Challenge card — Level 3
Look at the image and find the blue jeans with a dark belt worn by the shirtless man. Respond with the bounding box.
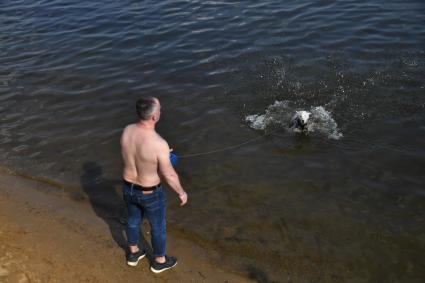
[123,182,167,257]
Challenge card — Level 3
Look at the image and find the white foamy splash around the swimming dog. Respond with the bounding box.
[245,101,343,140]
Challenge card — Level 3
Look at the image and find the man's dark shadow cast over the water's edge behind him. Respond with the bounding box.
[80,162,153,260]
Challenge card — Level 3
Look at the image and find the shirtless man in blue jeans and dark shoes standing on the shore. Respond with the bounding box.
[121,97,187,273]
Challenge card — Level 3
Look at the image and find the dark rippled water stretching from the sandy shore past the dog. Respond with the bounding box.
[0,0,425,282]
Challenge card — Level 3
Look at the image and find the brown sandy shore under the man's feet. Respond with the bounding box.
[0,172,252,283]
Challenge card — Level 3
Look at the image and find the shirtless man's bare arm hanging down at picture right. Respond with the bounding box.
[158,141,187,205]
